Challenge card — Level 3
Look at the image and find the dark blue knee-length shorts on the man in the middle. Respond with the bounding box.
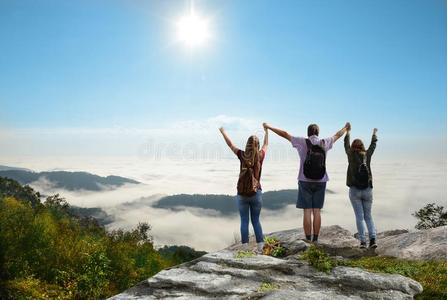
[296,181,326,209]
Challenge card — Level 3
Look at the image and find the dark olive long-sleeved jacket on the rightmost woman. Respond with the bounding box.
[345,132,377,188]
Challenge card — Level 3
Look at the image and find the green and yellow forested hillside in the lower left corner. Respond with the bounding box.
[0,177,203,299]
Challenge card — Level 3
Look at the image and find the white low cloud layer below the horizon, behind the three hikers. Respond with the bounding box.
[4,157,447,250]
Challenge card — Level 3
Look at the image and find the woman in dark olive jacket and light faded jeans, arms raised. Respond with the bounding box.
[345,128,377,248]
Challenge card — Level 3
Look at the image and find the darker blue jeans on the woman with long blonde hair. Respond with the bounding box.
[236,190,264,243]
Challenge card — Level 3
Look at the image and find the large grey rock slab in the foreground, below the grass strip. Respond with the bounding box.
[112,250,422,300]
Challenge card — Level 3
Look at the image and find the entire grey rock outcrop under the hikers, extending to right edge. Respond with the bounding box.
[107,226,447,300]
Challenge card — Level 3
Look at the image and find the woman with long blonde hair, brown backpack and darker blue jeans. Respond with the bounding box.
[219,127,268,253]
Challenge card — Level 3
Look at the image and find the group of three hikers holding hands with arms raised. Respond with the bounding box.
[220,123,377,252]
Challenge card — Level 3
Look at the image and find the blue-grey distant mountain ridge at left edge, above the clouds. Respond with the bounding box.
[0,167,140,191]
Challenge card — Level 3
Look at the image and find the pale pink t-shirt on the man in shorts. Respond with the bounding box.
[291,135,334,182]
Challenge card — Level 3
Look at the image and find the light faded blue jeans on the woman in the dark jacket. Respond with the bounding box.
[349,187,376,242]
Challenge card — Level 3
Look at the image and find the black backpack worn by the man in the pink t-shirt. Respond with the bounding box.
[303,139,326,180]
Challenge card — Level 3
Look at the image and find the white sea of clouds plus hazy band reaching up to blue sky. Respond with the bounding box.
[0,115,447,250]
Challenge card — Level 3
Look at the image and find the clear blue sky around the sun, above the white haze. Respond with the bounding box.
[0,0,447,158]
